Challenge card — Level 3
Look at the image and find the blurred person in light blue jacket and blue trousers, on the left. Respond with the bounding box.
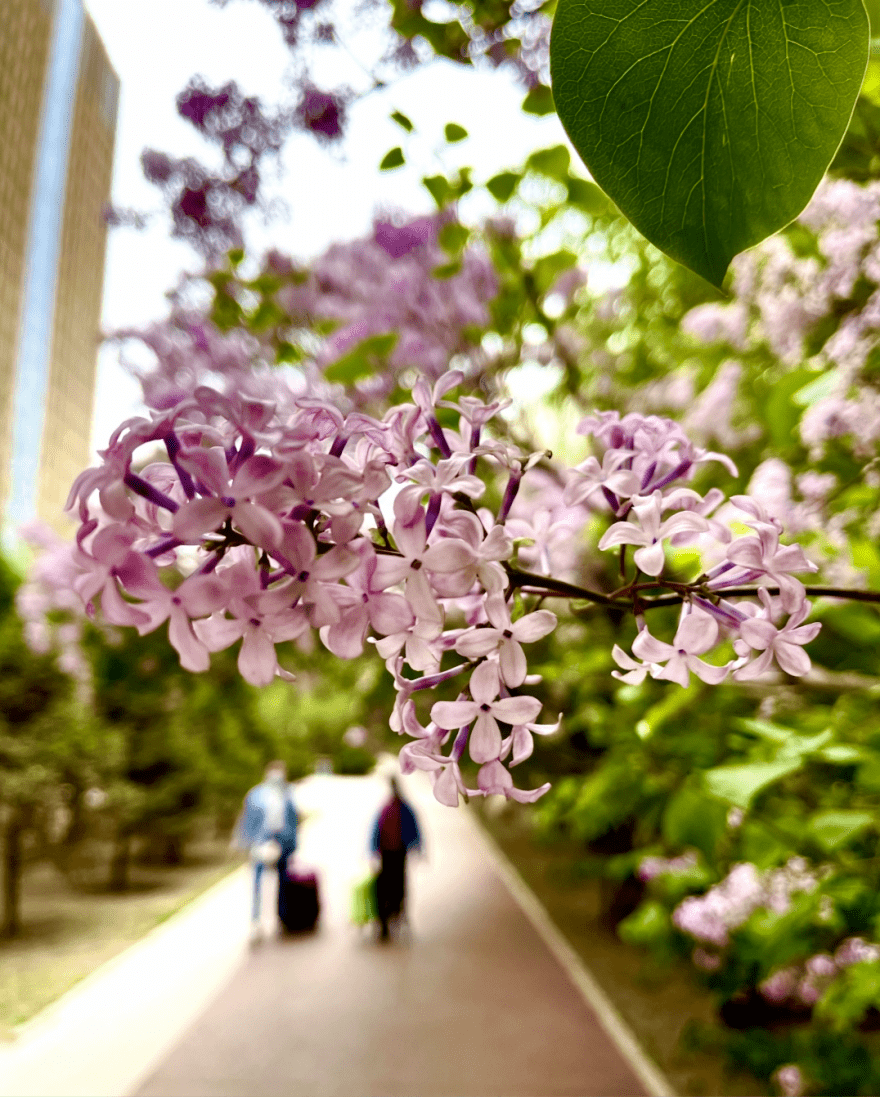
[236,761,298,940]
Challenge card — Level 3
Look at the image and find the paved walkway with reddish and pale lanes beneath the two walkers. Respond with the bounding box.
[0,763,668,1097]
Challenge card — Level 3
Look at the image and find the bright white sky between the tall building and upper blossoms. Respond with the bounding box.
[80,0,565,450]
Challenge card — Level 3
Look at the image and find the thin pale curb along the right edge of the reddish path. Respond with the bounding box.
[465,807,677,1097]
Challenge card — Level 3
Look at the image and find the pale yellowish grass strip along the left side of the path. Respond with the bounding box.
[0,841,241,1039]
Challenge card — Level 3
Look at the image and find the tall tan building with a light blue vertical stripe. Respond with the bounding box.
[0,0,119,540]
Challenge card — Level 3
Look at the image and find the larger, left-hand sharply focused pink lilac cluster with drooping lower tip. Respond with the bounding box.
[68,372,556,805]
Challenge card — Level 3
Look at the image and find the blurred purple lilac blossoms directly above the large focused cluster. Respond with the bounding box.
[120,212,498,410]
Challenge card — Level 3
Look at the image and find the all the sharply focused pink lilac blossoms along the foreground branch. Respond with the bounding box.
[61,379,819,805]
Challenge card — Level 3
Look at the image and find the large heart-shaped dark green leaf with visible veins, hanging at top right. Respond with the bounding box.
[550,0,868,285]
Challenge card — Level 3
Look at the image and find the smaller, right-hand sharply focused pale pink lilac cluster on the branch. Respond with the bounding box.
[565,411,820,686]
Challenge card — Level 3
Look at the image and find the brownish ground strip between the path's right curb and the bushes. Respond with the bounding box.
[477,804,769,1097]
